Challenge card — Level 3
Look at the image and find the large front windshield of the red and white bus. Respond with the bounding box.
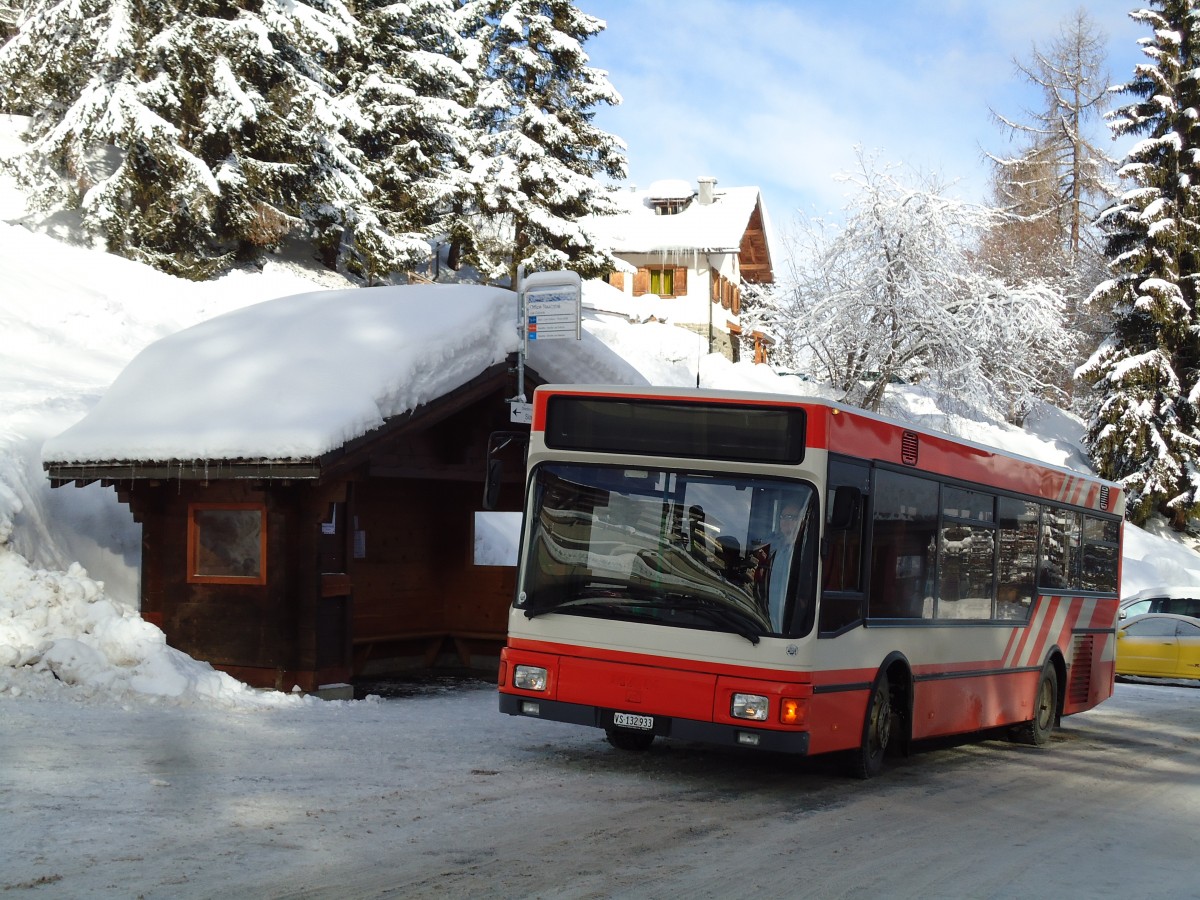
[516,463,818,643]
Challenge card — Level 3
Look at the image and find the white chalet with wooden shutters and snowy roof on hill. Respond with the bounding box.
[586,178,775,362]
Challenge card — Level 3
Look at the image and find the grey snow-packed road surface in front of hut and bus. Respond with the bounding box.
[0,684,1200,900]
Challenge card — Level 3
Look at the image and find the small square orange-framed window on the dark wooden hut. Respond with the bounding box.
[187,503,266,584]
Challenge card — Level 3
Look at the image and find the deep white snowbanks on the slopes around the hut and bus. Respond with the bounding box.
[0,114,1200,708]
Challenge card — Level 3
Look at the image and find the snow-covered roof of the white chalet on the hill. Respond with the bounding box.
[584,182,762,253]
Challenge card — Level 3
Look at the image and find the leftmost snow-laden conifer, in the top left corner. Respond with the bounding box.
[0,0,220,273]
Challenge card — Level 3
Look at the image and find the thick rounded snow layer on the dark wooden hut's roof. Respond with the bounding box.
[43,284,647,464]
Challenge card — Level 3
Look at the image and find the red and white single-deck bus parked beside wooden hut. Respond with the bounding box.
[499,385,1124,778]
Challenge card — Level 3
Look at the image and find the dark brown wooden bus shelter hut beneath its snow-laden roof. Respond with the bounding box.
[46,362,540,691]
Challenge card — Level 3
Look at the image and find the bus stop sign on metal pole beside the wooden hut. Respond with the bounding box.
[509,265,583,425]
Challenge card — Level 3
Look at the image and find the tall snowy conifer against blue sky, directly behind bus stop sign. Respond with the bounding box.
[460,0,625,280]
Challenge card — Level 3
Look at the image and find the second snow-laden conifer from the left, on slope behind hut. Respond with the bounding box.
[171,0,372,269]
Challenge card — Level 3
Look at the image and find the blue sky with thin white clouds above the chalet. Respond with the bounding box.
[577,0,1148,229]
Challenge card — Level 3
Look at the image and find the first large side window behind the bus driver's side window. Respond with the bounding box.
[866,470,938,619]
